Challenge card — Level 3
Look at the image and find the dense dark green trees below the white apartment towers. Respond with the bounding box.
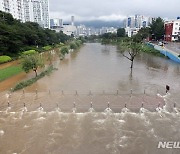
[0,11,69,55]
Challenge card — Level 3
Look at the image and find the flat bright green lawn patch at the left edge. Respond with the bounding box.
[0,65,23,82]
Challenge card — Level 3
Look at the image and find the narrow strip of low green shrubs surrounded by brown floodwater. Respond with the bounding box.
[11,66,55,92]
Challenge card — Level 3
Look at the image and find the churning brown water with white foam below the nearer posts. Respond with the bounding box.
[0,103,180,154]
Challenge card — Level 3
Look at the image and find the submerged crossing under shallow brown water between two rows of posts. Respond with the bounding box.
[0,91,167,113]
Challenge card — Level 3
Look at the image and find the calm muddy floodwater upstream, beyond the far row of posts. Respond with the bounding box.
[27,43,180,93]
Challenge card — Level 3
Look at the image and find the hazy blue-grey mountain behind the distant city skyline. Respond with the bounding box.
[63,20,123,28]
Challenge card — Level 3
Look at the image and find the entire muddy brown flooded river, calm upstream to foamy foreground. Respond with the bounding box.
[0,43,180,154]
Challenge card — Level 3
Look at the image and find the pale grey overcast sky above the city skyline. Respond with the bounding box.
[49,0,180,21]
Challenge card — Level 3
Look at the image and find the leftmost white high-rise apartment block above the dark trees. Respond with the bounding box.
[0,0,24,21]
